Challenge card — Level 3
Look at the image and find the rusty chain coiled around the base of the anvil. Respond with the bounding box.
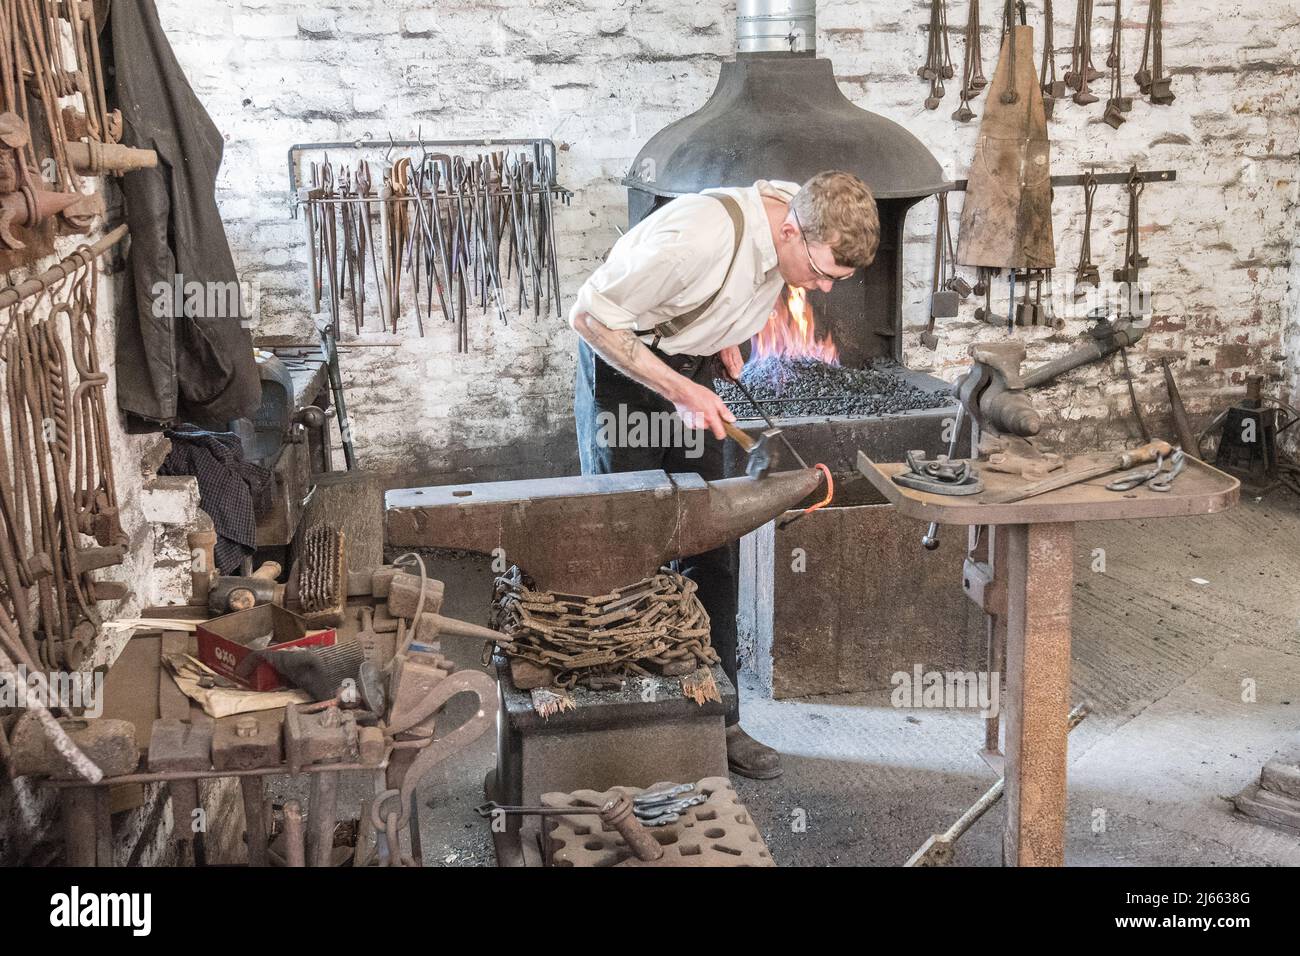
[493,567,719,688]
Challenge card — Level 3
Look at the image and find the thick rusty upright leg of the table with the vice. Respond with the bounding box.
[1002,523,1074,866]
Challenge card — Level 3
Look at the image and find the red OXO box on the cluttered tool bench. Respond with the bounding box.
[195,604,337,691]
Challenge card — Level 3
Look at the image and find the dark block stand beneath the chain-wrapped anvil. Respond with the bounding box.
[484,653,736,866]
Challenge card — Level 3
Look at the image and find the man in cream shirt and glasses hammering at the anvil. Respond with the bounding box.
[569,172,880,779]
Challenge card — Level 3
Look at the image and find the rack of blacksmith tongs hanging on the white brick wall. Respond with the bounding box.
[289,139,573,352]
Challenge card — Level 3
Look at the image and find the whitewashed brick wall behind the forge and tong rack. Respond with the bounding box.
[159,0,1300,475]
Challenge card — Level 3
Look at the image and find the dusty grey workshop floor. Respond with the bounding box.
[276,481,1300,866]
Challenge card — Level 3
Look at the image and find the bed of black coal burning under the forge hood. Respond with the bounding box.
[714,356,953,419]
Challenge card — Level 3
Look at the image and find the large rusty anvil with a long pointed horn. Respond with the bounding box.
[384,468,822,594]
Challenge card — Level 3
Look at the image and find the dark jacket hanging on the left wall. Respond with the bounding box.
[105,0,261,428]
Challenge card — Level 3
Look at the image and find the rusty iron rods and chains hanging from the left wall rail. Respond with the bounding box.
[0,233,126,669]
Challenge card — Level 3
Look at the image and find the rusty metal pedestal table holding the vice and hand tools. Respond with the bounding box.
[858,453,1240,866]
